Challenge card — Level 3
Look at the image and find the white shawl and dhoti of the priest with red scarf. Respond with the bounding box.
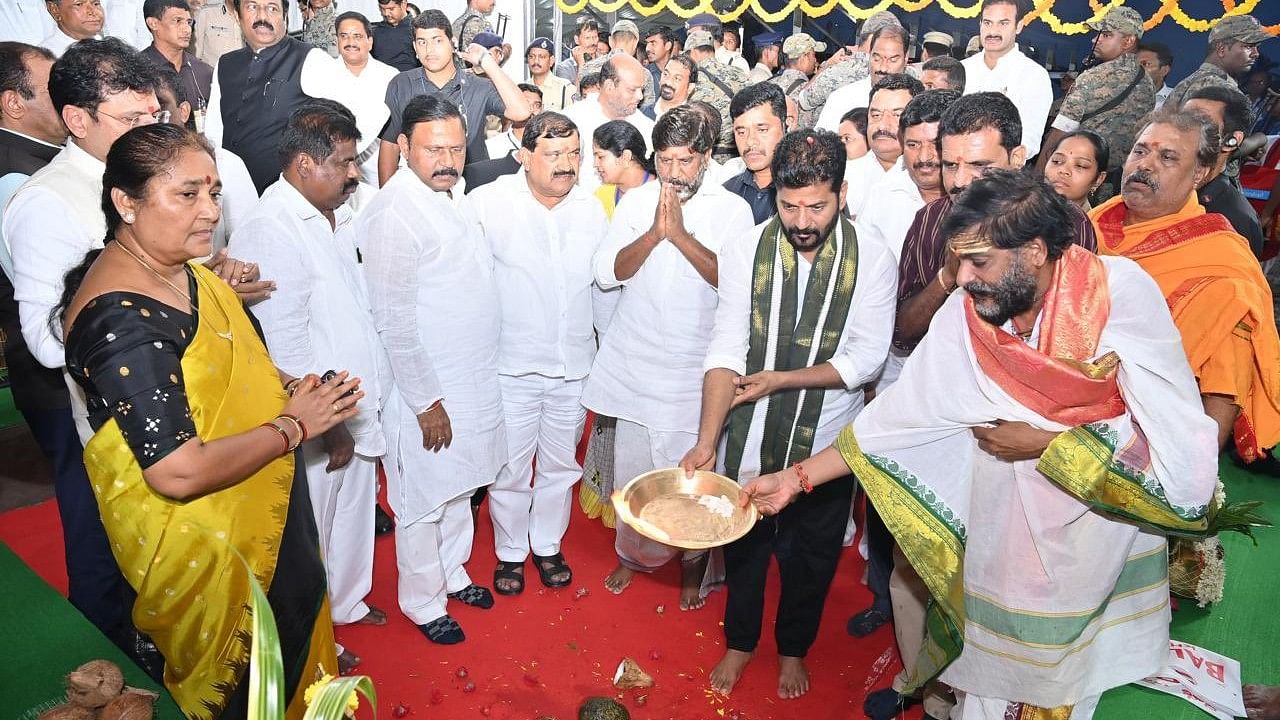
[854,258,1217,719]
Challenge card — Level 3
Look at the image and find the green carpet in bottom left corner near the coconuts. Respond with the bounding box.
[0,542,183,720]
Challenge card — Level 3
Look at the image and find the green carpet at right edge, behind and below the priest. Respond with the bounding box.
[1094,457,1280,720]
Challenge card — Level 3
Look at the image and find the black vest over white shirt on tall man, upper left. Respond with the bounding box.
[218,37,311,195]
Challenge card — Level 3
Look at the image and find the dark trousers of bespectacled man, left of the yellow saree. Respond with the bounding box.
[23,409,133,638]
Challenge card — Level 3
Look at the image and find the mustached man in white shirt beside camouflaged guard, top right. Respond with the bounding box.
[960,0,1053,152]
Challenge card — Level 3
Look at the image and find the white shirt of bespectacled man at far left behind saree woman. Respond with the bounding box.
[3,140,106,368]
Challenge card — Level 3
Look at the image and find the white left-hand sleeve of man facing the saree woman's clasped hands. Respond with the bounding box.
[227,215,314,378]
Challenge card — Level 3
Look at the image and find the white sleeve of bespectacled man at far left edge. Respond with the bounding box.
[4,187,91,368]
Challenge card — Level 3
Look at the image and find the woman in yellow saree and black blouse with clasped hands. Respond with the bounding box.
[61,124,364,719]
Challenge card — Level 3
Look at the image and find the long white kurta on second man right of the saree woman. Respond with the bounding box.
[356,170,506,524]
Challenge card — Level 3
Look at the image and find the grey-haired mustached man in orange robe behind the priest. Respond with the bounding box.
[1089,110,1280,462]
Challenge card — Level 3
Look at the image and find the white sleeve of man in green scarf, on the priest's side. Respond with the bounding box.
[829,229,897,389]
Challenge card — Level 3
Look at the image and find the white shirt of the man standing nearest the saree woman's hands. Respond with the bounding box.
[228,177,390,457]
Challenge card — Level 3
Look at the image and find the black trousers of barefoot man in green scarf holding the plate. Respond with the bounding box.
[724,477,854,657]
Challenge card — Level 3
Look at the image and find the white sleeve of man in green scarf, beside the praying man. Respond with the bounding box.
[703,228,760,375]
